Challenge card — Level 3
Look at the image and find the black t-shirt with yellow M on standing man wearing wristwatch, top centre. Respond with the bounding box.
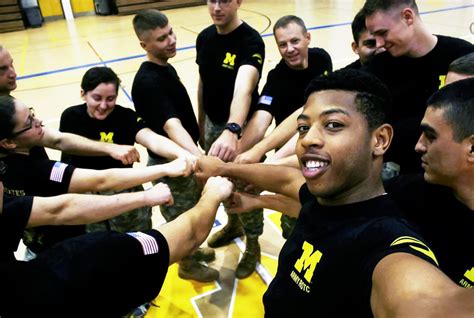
[196,22,265,124]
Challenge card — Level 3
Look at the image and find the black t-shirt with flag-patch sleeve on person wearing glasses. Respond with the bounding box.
[3,154,85,253]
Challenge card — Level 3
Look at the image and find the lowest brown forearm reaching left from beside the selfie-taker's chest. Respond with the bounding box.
[226,192,301,218]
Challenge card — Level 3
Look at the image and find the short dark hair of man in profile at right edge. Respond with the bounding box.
[426,78,474,142]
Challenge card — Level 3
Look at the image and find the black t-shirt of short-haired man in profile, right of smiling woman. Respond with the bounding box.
[132,62,199,158]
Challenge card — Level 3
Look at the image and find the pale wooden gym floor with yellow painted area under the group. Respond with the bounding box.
[4,0,474,317]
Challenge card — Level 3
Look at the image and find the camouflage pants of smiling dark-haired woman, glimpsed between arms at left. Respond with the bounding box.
[86,185,152,233]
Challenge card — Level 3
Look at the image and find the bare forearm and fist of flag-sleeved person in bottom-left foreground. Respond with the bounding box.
[158,177,233,264]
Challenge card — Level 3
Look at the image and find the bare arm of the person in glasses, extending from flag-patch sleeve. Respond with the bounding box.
[68,158,194,193]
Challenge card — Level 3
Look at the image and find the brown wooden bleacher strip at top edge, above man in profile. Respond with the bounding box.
[115,0,206,15]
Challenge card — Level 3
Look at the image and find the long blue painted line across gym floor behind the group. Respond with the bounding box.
[17,5,474,82]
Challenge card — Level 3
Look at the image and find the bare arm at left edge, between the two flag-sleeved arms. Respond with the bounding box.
[27,183,173,227]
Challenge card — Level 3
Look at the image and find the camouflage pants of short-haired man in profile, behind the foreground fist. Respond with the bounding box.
[148,158,201,222]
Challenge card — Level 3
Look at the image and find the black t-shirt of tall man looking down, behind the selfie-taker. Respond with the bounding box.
[363,35,474,173]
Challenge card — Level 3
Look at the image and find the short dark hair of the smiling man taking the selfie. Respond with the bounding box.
[305,69,391,131]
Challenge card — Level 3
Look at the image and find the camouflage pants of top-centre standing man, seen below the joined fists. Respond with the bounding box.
[204,116,263,238]
